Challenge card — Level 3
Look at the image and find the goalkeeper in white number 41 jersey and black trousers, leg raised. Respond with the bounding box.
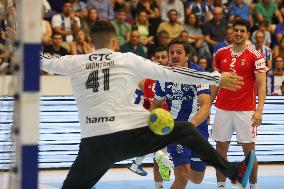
[42,21,255,189]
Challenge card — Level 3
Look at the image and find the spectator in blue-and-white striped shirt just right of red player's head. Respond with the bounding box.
[254,31,272,69]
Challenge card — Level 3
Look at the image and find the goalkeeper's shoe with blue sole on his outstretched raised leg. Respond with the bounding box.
[232,151,255,189]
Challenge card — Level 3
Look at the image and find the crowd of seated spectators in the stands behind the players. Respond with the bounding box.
[0,0,284,95]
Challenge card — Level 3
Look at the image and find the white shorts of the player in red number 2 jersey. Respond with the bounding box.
[210,108,257,143]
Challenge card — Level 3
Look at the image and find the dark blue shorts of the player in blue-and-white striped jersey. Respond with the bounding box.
[167,125,208,172]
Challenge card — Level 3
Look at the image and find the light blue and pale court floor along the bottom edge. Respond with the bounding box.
[35,164,284,189]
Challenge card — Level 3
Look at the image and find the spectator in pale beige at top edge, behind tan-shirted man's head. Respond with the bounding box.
[160,0,184,24]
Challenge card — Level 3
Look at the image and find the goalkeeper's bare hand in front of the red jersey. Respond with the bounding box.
[219,72,244,91]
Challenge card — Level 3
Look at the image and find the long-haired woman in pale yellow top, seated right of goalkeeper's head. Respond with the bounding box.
[135,10,154,46]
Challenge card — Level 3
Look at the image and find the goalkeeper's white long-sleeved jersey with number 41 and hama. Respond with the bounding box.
[41,49,220,138]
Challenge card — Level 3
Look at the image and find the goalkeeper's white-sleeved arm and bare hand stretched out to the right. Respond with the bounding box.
[128,53,242,90]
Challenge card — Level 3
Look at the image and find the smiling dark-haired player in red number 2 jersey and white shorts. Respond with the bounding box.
[211,19,266,189]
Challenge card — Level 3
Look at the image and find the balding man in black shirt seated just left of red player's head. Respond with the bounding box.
[203,7,227,48]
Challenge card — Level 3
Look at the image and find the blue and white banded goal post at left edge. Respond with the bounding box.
[12,0,42,189]
